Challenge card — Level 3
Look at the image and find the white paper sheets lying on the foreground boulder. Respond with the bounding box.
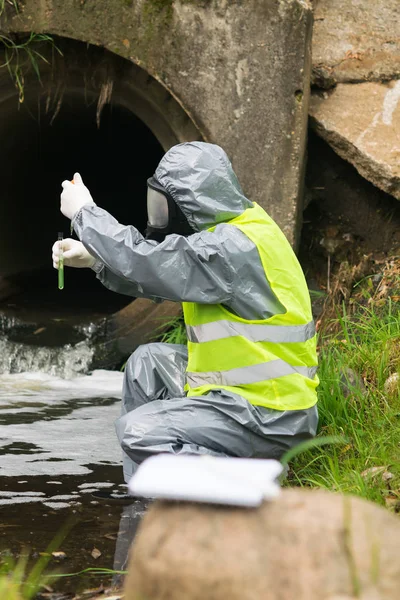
[128,454,283,506]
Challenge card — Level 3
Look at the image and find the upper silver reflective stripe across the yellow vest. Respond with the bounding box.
[186,320,315,343]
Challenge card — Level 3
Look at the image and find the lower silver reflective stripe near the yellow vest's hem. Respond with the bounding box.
[186,359,317,387]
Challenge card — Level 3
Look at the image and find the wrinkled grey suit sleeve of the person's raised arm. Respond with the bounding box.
[73,205,232,304]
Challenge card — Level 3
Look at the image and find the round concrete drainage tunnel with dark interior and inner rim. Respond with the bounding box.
[0,39,200,370]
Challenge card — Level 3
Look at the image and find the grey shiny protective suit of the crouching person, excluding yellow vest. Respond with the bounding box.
[73,142,318,481]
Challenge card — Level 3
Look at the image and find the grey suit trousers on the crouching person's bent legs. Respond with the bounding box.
[116,344,318,481]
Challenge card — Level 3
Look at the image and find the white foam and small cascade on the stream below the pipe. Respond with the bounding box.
[0,338,123,492]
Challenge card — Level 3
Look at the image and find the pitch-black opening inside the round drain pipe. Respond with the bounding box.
[0,93,163,319]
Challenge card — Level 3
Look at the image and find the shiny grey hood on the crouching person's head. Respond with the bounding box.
[155,142,253,231]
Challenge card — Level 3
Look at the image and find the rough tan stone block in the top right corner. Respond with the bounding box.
[312,0,400,88]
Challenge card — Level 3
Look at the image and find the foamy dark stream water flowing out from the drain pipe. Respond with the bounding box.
[0,326,148,597]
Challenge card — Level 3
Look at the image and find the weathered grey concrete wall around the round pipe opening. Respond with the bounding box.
[0,0,312,245]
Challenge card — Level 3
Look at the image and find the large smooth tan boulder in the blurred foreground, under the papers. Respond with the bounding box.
[124,489,400,600]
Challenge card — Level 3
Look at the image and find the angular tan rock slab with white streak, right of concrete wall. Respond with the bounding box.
[310,80,400,200]
